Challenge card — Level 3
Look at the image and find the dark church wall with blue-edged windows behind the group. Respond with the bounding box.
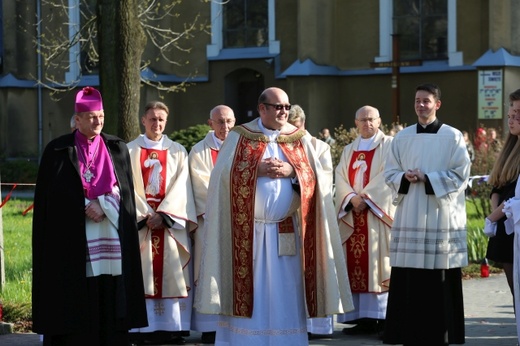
[0,0,520,158]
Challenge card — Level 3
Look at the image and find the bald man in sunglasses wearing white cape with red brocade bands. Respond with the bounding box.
[195,87,353,346]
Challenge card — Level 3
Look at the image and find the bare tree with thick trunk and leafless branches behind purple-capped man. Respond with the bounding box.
[31,0,209,140]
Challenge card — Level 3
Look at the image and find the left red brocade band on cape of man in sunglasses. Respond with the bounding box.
[230,136,267,317]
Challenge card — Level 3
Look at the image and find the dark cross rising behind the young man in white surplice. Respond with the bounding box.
[370,34,422,124]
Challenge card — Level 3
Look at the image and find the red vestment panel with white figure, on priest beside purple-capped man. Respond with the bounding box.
[141,148,168,298]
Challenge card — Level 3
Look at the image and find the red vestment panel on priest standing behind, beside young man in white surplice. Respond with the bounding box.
[345,149,375,293]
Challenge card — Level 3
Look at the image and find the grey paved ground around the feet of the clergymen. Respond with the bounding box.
[0,274,517,346]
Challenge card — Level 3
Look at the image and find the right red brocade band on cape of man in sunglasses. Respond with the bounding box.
[279,138,317,317]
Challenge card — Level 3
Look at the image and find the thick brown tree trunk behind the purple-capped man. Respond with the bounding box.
[98,0,146,141]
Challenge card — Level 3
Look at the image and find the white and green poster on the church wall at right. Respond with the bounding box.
[478,70,503,119]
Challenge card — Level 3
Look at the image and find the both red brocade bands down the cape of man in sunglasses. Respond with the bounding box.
[230,136,317,317]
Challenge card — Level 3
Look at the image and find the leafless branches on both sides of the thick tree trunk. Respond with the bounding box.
[34,0,209,92]
